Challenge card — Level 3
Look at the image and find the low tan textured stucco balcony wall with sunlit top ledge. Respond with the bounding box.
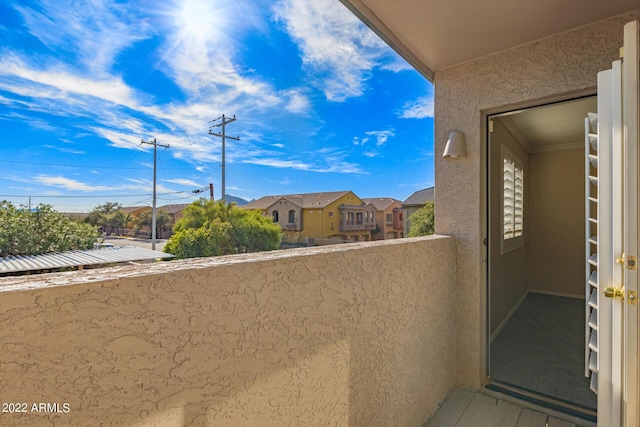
[0,236,456,426]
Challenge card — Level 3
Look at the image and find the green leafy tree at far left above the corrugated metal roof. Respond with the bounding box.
[0,200,98,257]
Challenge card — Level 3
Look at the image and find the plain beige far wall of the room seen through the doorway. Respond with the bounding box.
[529,148,586,298]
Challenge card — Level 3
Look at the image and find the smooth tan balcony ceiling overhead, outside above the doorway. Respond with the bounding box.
[341,0,640,79]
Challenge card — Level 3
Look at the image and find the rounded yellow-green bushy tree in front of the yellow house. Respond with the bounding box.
[164,199,281,258]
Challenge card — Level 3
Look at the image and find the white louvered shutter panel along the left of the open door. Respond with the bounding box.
[585,56,624,427]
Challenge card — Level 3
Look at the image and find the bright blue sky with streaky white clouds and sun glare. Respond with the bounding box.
[0,0,434,212]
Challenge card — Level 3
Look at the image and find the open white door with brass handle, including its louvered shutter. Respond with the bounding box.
[585,22,640,427]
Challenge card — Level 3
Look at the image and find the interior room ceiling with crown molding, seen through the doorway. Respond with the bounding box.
[494,96,598,153]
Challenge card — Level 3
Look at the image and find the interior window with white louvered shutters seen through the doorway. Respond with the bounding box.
[502,147,524,253]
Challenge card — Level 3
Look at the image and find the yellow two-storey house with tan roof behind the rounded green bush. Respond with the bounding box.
[243,191,375,242]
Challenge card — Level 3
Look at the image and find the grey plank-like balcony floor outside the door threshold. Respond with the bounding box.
[426,389,595,427]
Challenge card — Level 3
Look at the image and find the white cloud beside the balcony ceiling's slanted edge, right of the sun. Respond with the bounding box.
[274,0,399,102]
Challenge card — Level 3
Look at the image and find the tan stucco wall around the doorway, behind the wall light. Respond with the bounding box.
[434,10,640,386]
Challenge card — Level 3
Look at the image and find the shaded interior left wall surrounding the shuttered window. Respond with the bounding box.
[489,119,531,336]
